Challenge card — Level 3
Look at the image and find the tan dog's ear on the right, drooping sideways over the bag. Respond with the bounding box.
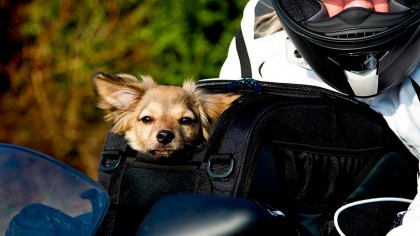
[183,80,240,140]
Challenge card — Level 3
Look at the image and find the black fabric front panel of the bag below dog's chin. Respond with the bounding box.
[97,152,211,235]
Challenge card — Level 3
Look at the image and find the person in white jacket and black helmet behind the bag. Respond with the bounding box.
[219,0,420,233]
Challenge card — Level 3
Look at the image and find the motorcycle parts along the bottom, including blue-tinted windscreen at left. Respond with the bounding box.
[0,143,411,236]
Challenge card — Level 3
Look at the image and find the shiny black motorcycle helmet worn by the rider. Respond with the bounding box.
[272,0,420,97]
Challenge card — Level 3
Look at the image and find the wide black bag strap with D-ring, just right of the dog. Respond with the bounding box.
[202,97,276,197]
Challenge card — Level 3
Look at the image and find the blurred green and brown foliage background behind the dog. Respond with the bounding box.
[0,0,247,178]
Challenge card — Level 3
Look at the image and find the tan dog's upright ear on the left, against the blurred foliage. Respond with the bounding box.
[92,72,156,131]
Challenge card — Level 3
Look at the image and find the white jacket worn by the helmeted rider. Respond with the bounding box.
[219,0,420,235]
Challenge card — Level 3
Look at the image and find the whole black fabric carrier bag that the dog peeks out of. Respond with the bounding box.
[98,80,418,235]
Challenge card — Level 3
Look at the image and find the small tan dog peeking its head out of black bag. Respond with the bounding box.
[93,72,239,159]
